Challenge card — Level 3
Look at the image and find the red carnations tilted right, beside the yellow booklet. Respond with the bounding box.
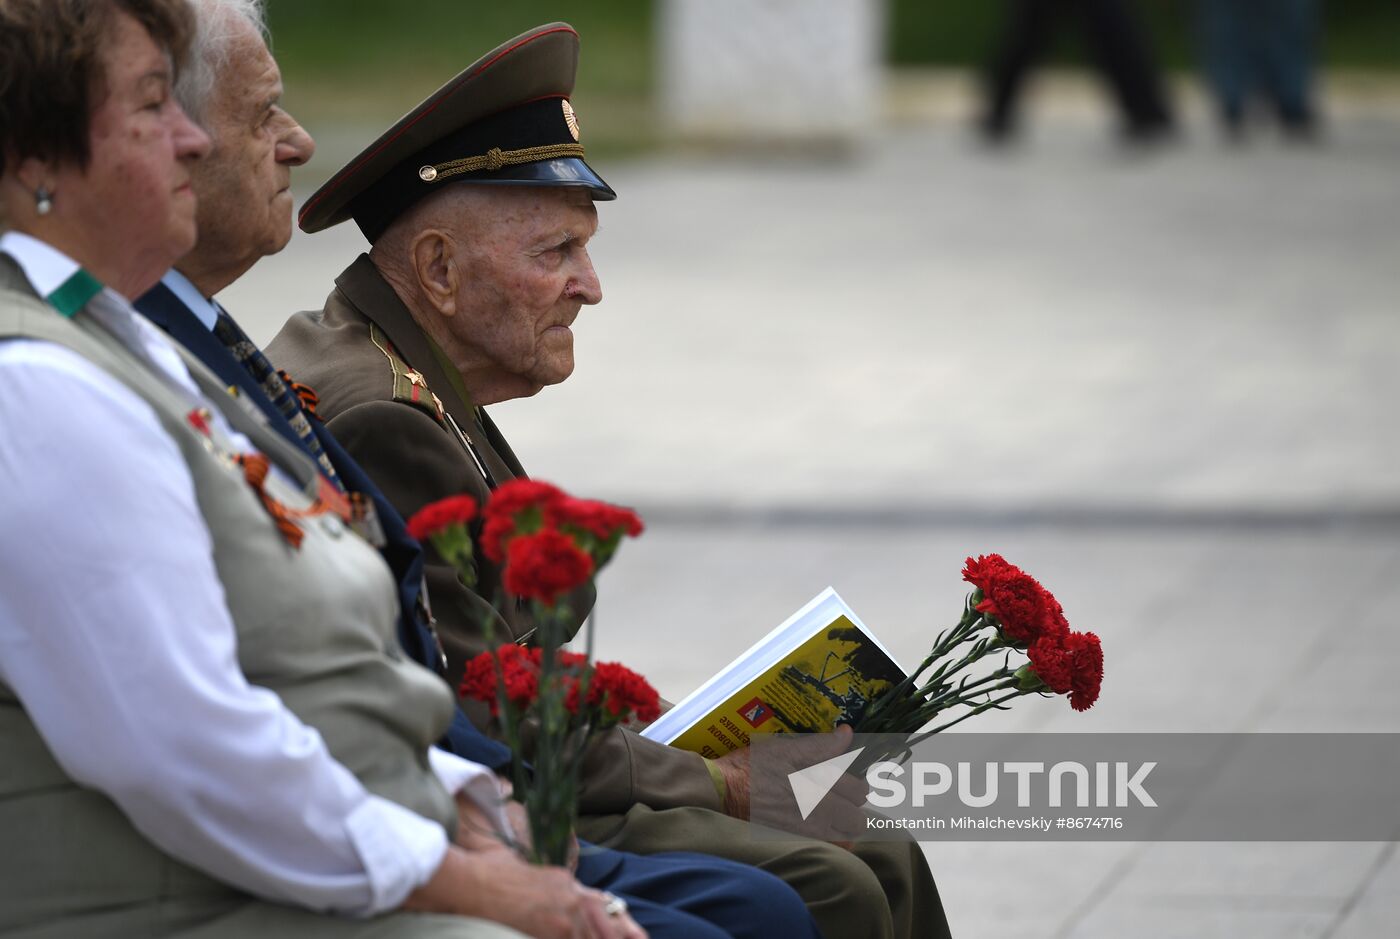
[855,554,1103,743]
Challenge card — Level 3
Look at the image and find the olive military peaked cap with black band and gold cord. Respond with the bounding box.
[300,22,617,242]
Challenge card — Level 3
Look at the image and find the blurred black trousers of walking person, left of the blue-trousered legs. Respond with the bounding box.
[984,0,1172,134]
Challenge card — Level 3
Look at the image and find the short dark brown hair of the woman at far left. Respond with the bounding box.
[0,0,195,172]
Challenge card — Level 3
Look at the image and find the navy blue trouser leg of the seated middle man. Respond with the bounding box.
[578,845,822,939]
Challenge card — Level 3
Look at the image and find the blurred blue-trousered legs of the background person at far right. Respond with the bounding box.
[1200,0,1317,139]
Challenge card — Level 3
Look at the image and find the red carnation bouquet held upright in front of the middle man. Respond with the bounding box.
[409,479,659,863]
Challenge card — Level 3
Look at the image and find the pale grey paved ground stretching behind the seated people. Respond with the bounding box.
[224,82,1400,939]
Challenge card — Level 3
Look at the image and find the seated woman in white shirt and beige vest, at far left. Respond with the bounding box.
[0,0,640,938]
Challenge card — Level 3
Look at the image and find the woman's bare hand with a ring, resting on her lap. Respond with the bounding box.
[403,847,647,939]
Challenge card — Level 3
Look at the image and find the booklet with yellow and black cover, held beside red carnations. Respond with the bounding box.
[641,588,904,758]
